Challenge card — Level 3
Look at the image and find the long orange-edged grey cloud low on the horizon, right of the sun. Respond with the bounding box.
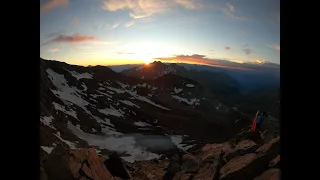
[155,54,280,73]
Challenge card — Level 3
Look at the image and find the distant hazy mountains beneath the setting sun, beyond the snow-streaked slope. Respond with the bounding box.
[122,61,280,117]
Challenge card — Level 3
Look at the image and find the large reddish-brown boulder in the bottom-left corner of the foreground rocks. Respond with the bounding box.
[43,145,114,180]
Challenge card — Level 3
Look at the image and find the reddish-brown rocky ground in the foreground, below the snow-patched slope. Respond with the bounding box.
[40,131,281,180]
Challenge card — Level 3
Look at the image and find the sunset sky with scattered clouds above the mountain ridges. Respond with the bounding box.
[40,0,280,65]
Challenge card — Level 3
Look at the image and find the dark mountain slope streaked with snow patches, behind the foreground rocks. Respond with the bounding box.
[40,58,251,161]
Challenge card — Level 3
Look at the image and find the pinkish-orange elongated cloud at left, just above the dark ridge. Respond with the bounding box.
[42,33,98,46]
